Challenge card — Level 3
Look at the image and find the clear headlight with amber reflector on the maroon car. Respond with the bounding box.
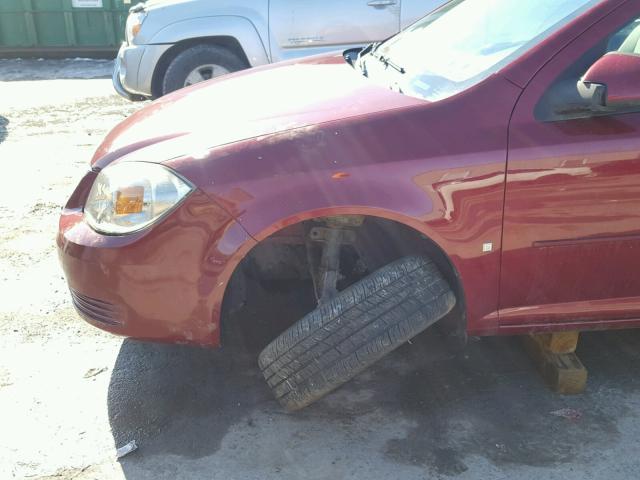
[84,162,193,235]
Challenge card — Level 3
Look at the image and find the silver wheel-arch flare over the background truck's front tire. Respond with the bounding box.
[144,15,269,67]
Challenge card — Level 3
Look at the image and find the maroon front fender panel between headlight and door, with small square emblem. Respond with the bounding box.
[169,76,520,334]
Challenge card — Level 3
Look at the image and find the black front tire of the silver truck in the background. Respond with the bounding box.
[162,44,248,95]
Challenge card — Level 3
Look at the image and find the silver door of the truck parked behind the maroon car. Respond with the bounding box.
[269,0,401,62]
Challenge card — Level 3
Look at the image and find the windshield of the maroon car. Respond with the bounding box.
[360,0,597,101]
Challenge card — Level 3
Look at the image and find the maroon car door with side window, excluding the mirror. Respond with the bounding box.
[499,6,640,329]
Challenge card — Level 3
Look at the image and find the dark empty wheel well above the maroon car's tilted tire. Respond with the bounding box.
[221,216,466,345]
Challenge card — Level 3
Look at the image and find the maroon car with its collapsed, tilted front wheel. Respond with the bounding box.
[58,0,640,409]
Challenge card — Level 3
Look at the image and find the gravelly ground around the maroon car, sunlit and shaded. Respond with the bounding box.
[0,60,640,480]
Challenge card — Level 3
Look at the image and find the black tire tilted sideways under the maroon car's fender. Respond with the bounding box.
[258,256,456,411]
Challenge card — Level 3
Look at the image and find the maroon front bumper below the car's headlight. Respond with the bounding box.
[57,172,253,346]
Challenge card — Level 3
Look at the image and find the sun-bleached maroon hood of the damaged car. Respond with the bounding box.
[91,54,420,168]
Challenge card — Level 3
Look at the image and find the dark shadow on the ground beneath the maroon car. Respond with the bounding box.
[108,293,640,480]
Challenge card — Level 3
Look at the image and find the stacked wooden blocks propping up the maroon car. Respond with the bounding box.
[524,335,587,395]
